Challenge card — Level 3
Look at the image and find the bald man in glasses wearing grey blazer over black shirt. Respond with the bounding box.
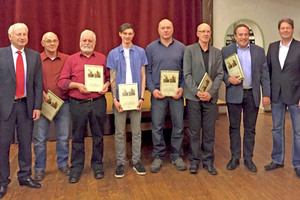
[183,23,224,175]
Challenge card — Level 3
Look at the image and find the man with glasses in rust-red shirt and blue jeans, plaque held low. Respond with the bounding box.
[33,32,70,181]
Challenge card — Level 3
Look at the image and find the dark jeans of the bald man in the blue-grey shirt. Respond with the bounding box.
[151,96,184,160]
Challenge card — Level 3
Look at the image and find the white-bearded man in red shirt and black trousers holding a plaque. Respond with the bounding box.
[57,30,110,183]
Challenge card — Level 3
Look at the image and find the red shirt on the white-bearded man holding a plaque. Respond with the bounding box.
[57,51,110,99]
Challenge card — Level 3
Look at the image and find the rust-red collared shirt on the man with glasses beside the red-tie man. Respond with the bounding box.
[40,52,69,100]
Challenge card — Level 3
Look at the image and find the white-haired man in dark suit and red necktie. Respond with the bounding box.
[0,23,43,198]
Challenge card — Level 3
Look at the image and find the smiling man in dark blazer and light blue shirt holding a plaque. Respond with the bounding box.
[222,24,270,172]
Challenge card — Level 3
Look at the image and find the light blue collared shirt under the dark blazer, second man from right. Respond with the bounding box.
[236,44,252,89]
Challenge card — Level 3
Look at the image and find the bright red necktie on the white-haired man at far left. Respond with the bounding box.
[16,51,25,98]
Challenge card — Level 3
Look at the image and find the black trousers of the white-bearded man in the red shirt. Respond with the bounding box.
[70,96,106,173]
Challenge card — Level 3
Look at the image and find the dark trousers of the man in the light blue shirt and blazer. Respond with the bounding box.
[227,90,258,160]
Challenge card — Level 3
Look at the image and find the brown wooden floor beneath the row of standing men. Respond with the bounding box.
[3,113,300,200]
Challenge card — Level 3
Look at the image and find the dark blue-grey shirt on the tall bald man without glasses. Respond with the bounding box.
[146,39,185,93]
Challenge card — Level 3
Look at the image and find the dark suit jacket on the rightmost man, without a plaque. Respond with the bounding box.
[267,39,300,105]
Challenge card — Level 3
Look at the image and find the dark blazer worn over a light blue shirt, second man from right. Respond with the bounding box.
[222,43,270,107]
